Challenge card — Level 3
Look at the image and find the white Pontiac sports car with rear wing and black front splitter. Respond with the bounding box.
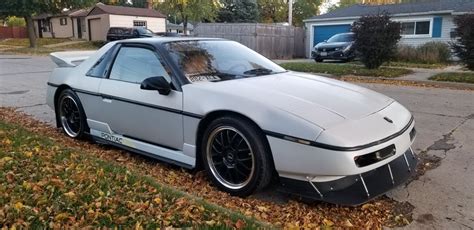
[47,38,417,205]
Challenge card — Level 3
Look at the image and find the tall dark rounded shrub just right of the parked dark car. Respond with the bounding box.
[352,13,401,69]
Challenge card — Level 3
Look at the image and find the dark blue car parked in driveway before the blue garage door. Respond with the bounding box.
[311,33,355,62]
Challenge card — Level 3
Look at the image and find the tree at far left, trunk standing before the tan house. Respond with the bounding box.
[0,0,94,48]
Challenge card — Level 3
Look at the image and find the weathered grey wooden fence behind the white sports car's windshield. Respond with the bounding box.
[193,23,305,59]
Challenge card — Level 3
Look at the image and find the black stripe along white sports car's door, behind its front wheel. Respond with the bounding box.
[48,82,204,119]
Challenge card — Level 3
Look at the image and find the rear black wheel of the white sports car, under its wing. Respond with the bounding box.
[56,89,87,138]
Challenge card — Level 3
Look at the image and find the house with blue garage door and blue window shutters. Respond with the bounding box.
[304,0,474,57]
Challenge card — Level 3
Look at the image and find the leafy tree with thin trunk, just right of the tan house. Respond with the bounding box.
[157,0,219,33]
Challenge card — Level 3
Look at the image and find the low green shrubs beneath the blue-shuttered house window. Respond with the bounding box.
[394,42,451,64]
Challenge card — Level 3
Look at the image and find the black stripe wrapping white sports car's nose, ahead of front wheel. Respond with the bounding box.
[264,116,414,151]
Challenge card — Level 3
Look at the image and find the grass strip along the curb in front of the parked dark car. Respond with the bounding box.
[281,62,412,78]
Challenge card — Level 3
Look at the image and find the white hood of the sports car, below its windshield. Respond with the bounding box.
[189,72,393,129]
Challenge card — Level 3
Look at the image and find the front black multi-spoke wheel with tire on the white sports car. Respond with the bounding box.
[201,117,272,196]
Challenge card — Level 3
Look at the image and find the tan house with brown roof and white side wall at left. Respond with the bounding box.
[33,3,166,41]
